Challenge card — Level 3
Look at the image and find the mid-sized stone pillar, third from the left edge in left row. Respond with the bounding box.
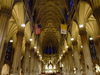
[24,42,30,75]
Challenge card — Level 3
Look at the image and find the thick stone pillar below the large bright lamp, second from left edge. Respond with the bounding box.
[13,32,24,75]
